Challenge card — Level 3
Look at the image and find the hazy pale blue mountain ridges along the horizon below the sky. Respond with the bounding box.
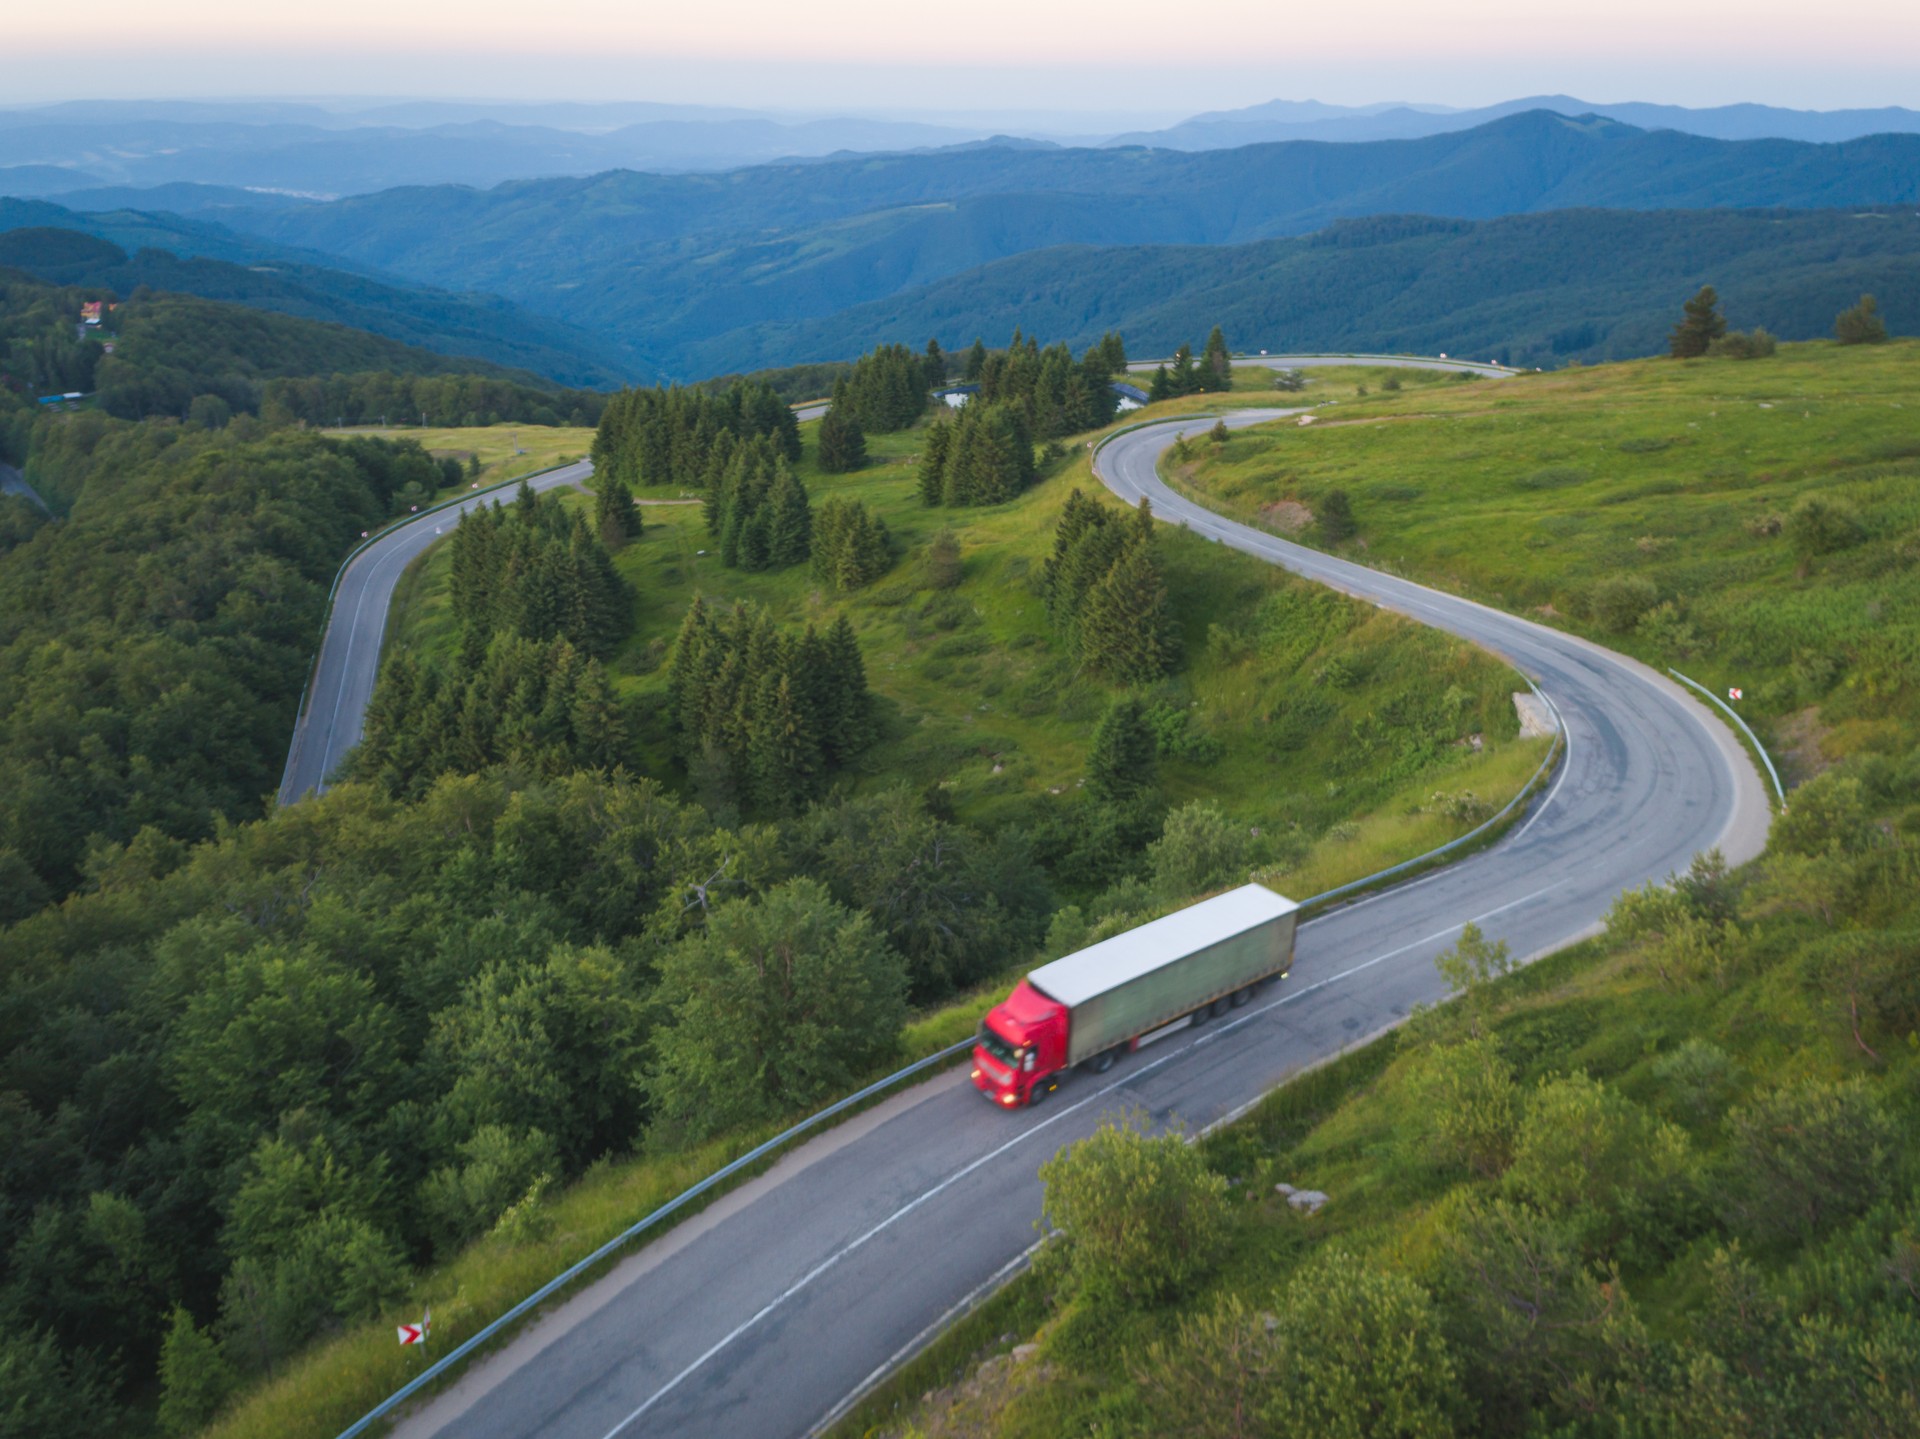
[0,96,1920,196]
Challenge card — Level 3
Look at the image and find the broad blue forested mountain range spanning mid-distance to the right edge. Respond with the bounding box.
[165,111,1920,380]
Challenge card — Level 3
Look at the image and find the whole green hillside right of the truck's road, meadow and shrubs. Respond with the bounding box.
[839,346,1920,1439]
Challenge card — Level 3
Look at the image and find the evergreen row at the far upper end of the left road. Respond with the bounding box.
[593,380,801,490]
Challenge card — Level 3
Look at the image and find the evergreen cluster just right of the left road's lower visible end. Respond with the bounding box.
[353,634,628,795]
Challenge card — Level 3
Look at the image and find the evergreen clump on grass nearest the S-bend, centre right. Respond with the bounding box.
[1041,490,1181,684]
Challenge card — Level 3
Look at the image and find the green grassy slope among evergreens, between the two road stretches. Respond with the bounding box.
[394,407,1540,893]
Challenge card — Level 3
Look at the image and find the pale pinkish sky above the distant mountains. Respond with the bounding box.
[0,0,1920,113]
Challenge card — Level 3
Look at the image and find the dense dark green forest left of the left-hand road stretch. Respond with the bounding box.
[0,415,456,899]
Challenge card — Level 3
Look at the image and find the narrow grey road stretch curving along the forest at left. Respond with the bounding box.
[278,461,593,805]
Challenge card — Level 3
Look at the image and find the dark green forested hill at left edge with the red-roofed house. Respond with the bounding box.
[0,261,603,426]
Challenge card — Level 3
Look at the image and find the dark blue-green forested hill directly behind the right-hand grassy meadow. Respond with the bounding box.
[706,209,1920,378]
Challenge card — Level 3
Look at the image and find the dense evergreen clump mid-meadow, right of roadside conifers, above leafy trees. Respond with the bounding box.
[668,599,874,815]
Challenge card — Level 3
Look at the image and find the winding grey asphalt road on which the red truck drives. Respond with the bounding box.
[371,365,1768,1439]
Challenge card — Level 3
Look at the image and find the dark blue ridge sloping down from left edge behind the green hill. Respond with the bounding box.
[0,200,628,388]
